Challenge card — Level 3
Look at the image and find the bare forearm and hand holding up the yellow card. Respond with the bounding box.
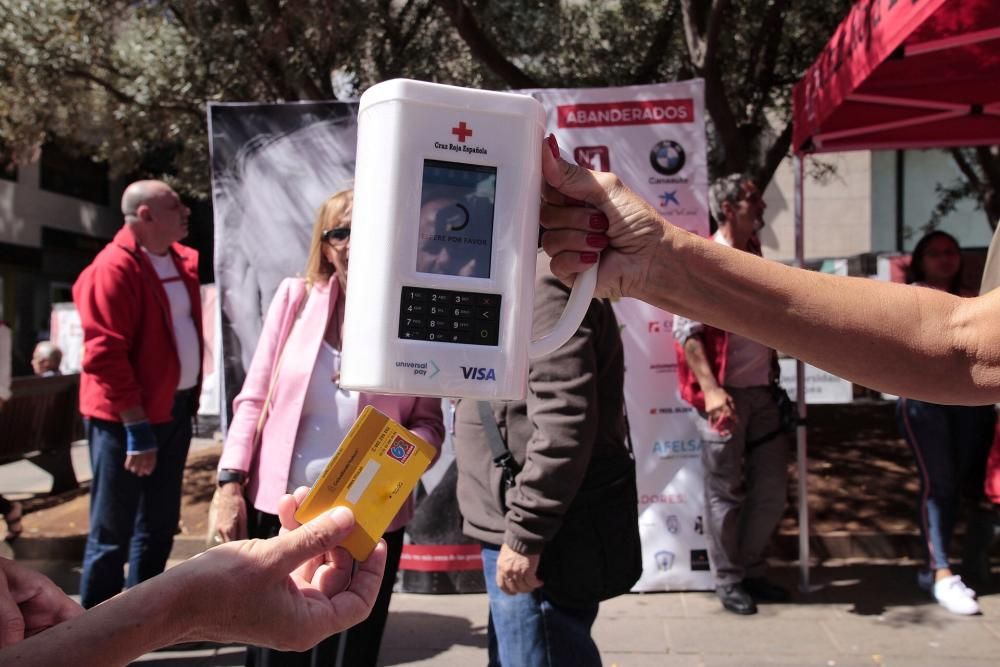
[0,506,386,667]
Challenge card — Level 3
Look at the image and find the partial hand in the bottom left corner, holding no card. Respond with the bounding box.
[0,558,83,648]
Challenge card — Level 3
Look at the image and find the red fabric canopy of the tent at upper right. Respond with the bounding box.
[792,0,1000,154]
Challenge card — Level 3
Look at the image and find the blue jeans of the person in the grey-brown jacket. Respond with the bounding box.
[483,544,601,667]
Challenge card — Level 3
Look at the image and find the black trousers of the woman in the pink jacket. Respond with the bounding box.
[246,505,405,667]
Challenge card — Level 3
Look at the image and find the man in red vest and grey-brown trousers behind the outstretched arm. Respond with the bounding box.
[674,174,789,614]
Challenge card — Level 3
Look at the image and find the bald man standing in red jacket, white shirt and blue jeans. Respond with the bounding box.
[73,181,203,608]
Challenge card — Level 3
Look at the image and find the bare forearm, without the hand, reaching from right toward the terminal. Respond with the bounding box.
[640,228,1000,404]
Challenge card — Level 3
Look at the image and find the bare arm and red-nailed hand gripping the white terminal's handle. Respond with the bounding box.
[542,135,1000,404]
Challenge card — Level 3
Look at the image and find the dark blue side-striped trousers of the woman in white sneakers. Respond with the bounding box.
[896,398,996,570]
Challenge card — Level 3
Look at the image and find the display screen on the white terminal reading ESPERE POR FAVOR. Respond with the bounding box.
[417,160,497,278]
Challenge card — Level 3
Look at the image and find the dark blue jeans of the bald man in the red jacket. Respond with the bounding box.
[80,389,194,609]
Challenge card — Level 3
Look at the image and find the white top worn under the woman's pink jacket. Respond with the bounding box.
[288,340,359,493]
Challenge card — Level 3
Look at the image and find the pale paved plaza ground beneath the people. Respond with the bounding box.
[0,430,1000,667]
